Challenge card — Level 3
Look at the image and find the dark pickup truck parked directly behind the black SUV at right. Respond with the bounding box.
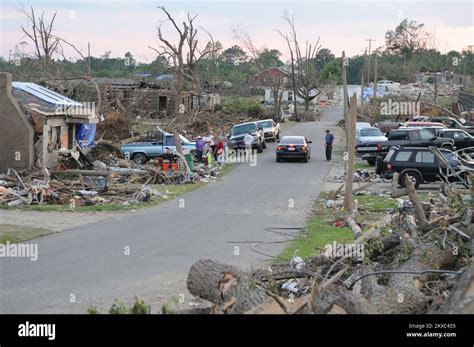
[356,128,456,163]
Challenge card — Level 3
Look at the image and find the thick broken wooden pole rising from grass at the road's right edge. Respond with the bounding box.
[344,93,357,213]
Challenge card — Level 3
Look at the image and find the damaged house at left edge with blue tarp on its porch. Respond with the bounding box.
[0,73,99,172]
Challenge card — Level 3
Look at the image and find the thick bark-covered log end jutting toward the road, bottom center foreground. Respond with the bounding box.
[187,259,268,314]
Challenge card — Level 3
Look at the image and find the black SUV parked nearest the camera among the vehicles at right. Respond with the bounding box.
[382,146,459,188]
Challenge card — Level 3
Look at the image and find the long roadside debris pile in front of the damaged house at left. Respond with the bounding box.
[0,148,226,209]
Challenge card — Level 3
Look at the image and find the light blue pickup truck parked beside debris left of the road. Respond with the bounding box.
[120,133,196,164]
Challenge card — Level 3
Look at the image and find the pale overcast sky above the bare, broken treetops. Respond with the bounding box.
[0,0,474,61]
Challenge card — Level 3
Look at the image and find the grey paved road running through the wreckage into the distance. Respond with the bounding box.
[0,108,342,313]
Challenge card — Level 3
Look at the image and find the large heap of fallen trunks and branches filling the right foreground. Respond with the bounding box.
[187,177,474,314]
